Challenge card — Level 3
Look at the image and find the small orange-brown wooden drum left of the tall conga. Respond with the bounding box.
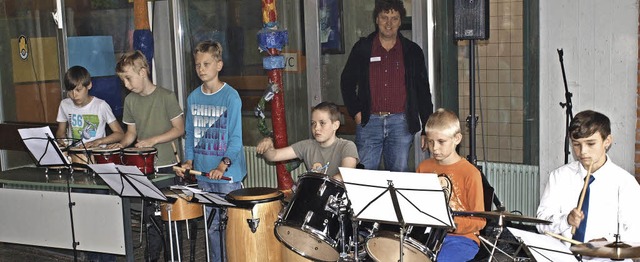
[160,190,204,221]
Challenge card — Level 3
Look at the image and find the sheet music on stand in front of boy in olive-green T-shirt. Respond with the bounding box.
[88,163,167,201]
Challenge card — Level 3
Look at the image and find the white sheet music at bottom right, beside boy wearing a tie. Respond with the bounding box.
[507,227,578,262]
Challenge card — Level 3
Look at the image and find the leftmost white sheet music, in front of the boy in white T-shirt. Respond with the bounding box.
[18,126,71,166]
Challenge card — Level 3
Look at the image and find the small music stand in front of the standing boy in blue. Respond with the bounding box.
[172,186,236,262]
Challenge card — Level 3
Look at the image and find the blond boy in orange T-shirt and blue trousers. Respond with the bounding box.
[416,108,485,262]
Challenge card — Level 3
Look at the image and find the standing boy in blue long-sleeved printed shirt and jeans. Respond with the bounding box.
[176,41,247,261]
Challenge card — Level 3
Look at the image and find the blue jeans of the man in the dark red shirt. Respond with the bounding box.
[356,114,413,172]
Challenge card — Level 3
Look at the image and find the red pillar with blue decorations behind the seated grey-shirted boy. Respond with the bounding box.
[256,0,293,193]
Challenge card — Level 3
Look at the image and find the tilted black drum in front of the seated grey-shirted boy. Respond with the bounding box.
[275,173,353,261]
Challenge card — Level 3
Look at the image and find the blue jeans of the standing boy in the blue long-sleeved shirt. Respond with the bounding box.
[198,181,242,262]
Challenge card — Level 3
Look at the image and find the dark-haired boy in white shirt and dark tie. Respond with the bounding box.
[537,110,640,256]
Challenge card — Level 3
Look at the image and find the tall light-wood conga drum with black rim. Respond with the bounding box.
[226,187,283,262]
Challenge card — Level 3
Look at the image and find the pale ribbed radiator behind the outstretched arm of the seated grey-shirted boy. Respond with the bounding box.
[242,146,307,188]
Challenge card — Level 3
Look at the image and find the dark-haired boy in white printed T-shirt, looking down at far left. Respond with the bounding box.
[56,66,124,148]
